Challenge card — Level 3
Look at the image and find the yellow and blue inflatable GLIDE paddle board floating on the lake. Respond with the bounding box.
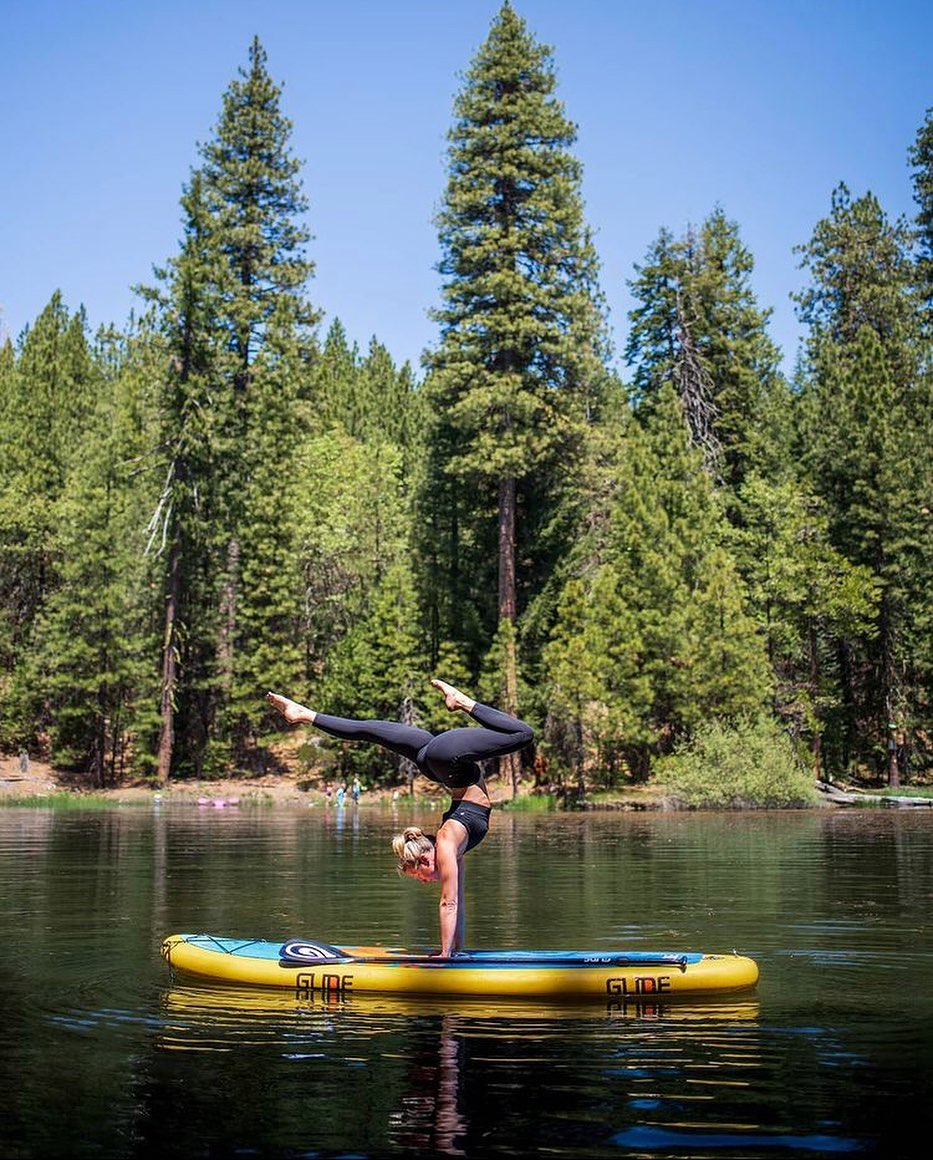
[162,935,758,1001]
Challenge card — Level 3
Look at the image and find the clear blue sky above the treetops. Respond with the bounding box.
[0,0,933,371]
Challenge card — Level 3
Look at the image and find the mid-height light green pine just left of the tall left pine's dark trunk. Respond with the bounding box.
[24,343,157,786]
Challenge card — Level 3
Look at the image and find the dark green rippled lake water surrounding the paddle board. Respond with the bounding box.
[0,802,933,1160]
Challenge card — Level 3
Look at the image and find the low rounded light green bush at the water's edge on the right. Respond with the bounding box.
[658,717,817,810]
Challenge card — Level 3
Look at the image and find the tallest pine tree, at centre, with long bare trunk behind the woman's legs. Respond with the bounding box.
[424,3,605,776]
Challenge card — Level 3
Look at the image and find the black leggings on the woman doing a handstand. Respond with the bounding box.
[314,701,535,789]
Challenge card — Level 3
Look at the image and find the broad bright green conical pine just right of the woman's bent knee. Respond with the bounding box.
[544,384,769,777]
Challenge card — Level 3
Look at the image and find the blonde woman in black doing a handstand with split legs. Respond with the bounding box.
[266,680,534,958]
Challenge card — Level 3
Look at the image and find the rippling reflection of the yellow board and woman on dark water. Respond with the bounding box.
[160,984,762,1157]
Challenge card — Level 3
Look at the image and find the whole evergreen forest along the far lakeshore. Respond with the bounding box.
[0,2,933,791]
